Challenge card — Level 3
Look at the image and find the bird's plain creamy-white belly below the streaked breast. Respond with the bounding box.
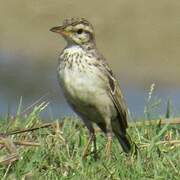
[59,67,116,122]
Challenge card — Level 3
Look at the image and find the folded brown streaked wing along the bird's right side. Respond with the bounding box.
[95,58,128,130]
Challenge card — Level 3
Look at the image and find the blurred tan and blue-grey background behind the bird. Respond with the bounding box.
[0,0,180,118]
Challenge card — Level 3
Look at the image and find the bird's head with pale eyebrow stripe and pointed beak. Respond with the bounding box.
[50,18,95,45]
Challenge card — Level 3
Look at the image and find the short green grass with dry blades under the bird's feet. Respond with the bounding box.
[0,103,180,180]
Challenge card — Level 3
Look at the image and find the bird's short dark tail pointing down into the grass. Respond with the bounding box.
[116,133,137,154]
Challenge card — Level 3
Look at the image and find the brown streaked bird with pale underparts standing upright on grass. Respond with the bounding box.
[50,17,136,158]
